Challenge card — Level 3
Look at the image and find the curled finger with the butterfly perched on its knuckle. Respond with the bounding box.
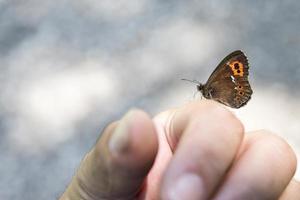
[161,101,244,200]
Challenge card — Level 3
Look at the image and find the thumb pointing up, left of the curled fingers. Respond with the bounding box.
[61,110,158,200]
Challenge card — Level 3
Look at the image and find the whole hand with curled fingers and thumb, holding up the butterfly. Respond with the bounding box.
[60,100,300,200]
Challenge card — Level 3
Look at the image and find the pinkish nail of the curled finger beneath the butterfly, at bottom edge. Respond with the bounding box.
[167,173,204,200]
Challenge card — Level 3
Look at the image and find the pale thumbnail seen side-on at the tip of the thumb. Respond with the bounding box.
[108,111,132,154]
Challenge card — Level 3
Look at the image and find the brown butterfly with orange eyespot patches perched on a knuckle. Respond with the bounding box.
[182,50,253,108]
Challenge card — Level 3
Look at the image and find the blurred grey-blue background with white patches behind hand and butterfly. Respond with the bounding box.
[0,0,300,200]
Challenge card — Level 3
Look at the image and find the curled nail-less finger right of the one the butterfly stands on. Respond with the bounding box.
[214,131,296,200]
